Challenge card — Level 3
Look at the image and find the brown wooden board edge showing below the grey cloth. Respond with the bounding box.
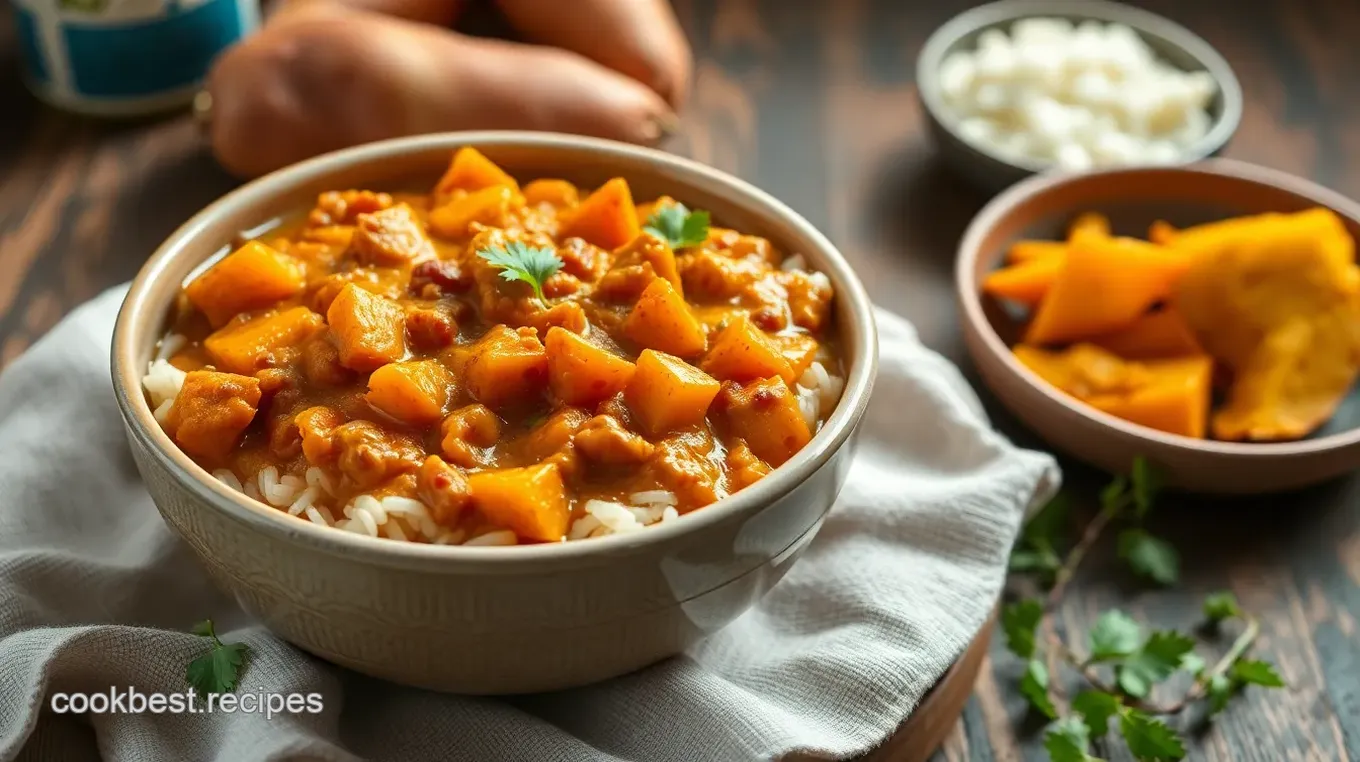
[782,612,997,762]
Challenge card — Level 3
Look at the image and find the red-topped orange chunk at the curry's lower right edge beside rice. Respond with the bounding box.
[717,377,812,467]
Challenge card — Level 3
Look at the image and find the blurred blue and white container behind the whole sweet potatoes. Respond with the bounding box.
[12,0,260,116]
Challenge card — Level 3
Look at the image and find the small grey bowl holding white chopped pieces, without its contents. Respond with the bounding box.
[917,0,1242,192]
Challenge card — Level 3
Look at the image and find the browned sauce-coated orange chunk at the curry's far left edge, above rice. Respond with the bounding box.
[166,370,260,459]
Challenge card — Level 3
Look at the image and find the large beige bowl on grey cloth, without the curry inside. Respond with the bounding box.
[113,132,877,694]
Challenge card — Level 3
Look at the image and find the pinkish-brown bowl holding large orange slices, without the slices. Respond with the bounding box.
[955,159,1360,494]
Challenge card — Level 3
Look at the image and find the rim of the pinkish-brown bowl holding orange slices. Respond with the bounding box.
[955,158,1360,451]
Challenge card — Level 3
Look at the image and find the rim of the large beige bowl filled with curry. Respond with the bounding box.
[112,131,879,572]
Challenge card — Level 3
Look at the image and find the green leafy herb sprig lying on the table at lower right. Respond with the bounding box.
[1001,459,1284,762]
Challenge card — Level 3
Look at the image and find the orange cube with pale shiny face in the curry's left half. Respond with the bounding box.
[326,283,407,373]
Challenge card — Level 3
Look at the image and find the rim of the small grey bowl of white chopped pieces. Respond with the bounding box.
[915,0,1243,174]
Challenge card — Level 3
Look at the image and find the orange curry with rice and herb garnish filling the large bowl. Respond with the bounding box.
[146,147,840,544]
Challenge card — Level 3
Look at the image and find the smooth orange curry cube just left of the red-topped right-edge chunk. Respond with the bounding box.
[623,346,721,434]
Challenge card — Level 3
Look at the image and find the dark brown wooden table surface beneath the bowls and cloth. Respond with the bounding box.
[0,0,1360,762]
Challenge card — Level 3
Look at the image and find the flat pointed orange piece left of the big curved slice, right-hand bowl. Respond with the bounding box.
[1025,237,1189,344]
